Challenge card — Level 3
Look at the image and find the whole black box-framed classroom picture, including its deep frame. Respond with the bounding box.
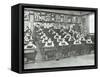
[11,4,98,73]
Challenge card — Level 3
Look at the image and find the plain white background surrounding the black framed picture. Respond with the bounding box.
[0,0,100,77]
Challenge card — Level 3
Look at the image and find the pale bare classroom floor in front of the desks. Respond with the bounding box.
[24,54,94,69]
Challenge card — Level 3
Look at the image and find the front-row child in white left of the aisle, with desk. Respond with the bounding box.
[24,41,38,63]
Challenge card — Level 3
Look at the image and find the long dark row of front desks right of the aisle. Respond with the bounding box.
[38,40,94,60]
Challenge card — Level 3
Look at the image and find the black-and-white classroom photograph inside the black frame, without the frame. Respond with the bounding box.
[24,8,95,69]
